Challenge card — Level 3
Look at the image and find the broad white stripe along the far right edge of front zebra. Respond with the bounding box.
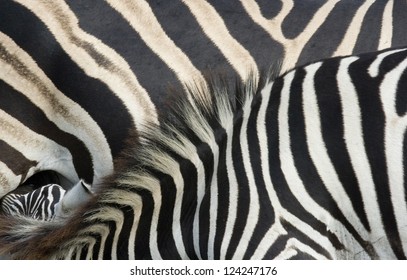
[380,54,407,255]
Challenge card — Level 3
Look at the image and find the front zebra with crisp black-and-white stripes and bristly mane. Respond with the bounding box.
[0,45,407,259]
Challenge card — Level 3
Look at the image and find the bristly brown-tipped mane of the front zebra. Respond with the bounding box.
[0,67,276,259]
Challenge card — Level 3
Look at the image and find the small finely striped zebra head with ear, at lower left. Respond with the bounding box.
[0,180,92,221]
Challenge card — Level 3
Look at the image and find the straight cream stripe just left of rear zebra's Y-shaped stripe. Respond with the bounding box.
[182,0,259,80]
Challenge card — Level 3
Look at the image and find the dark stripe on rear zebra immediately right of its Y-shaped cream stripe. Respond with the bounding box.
[297,1,363,65]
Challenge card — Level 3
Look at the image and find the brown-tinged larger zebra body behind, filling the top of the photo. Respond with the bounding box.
[0,0,407,200]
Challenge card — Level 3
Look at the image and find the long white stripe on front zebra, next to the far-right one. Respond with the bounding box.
[336,57,395,258]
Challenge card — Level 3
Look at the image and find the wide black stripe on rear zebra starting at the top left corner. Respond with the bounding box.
[0,1,132,160]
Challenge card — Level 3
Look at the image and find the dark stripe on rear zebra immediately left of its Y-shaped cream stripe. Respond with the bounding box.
[209,0,284,74]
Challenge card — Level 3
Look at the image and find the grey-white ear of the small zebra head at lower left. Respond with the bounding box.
[55,180,93,218]
